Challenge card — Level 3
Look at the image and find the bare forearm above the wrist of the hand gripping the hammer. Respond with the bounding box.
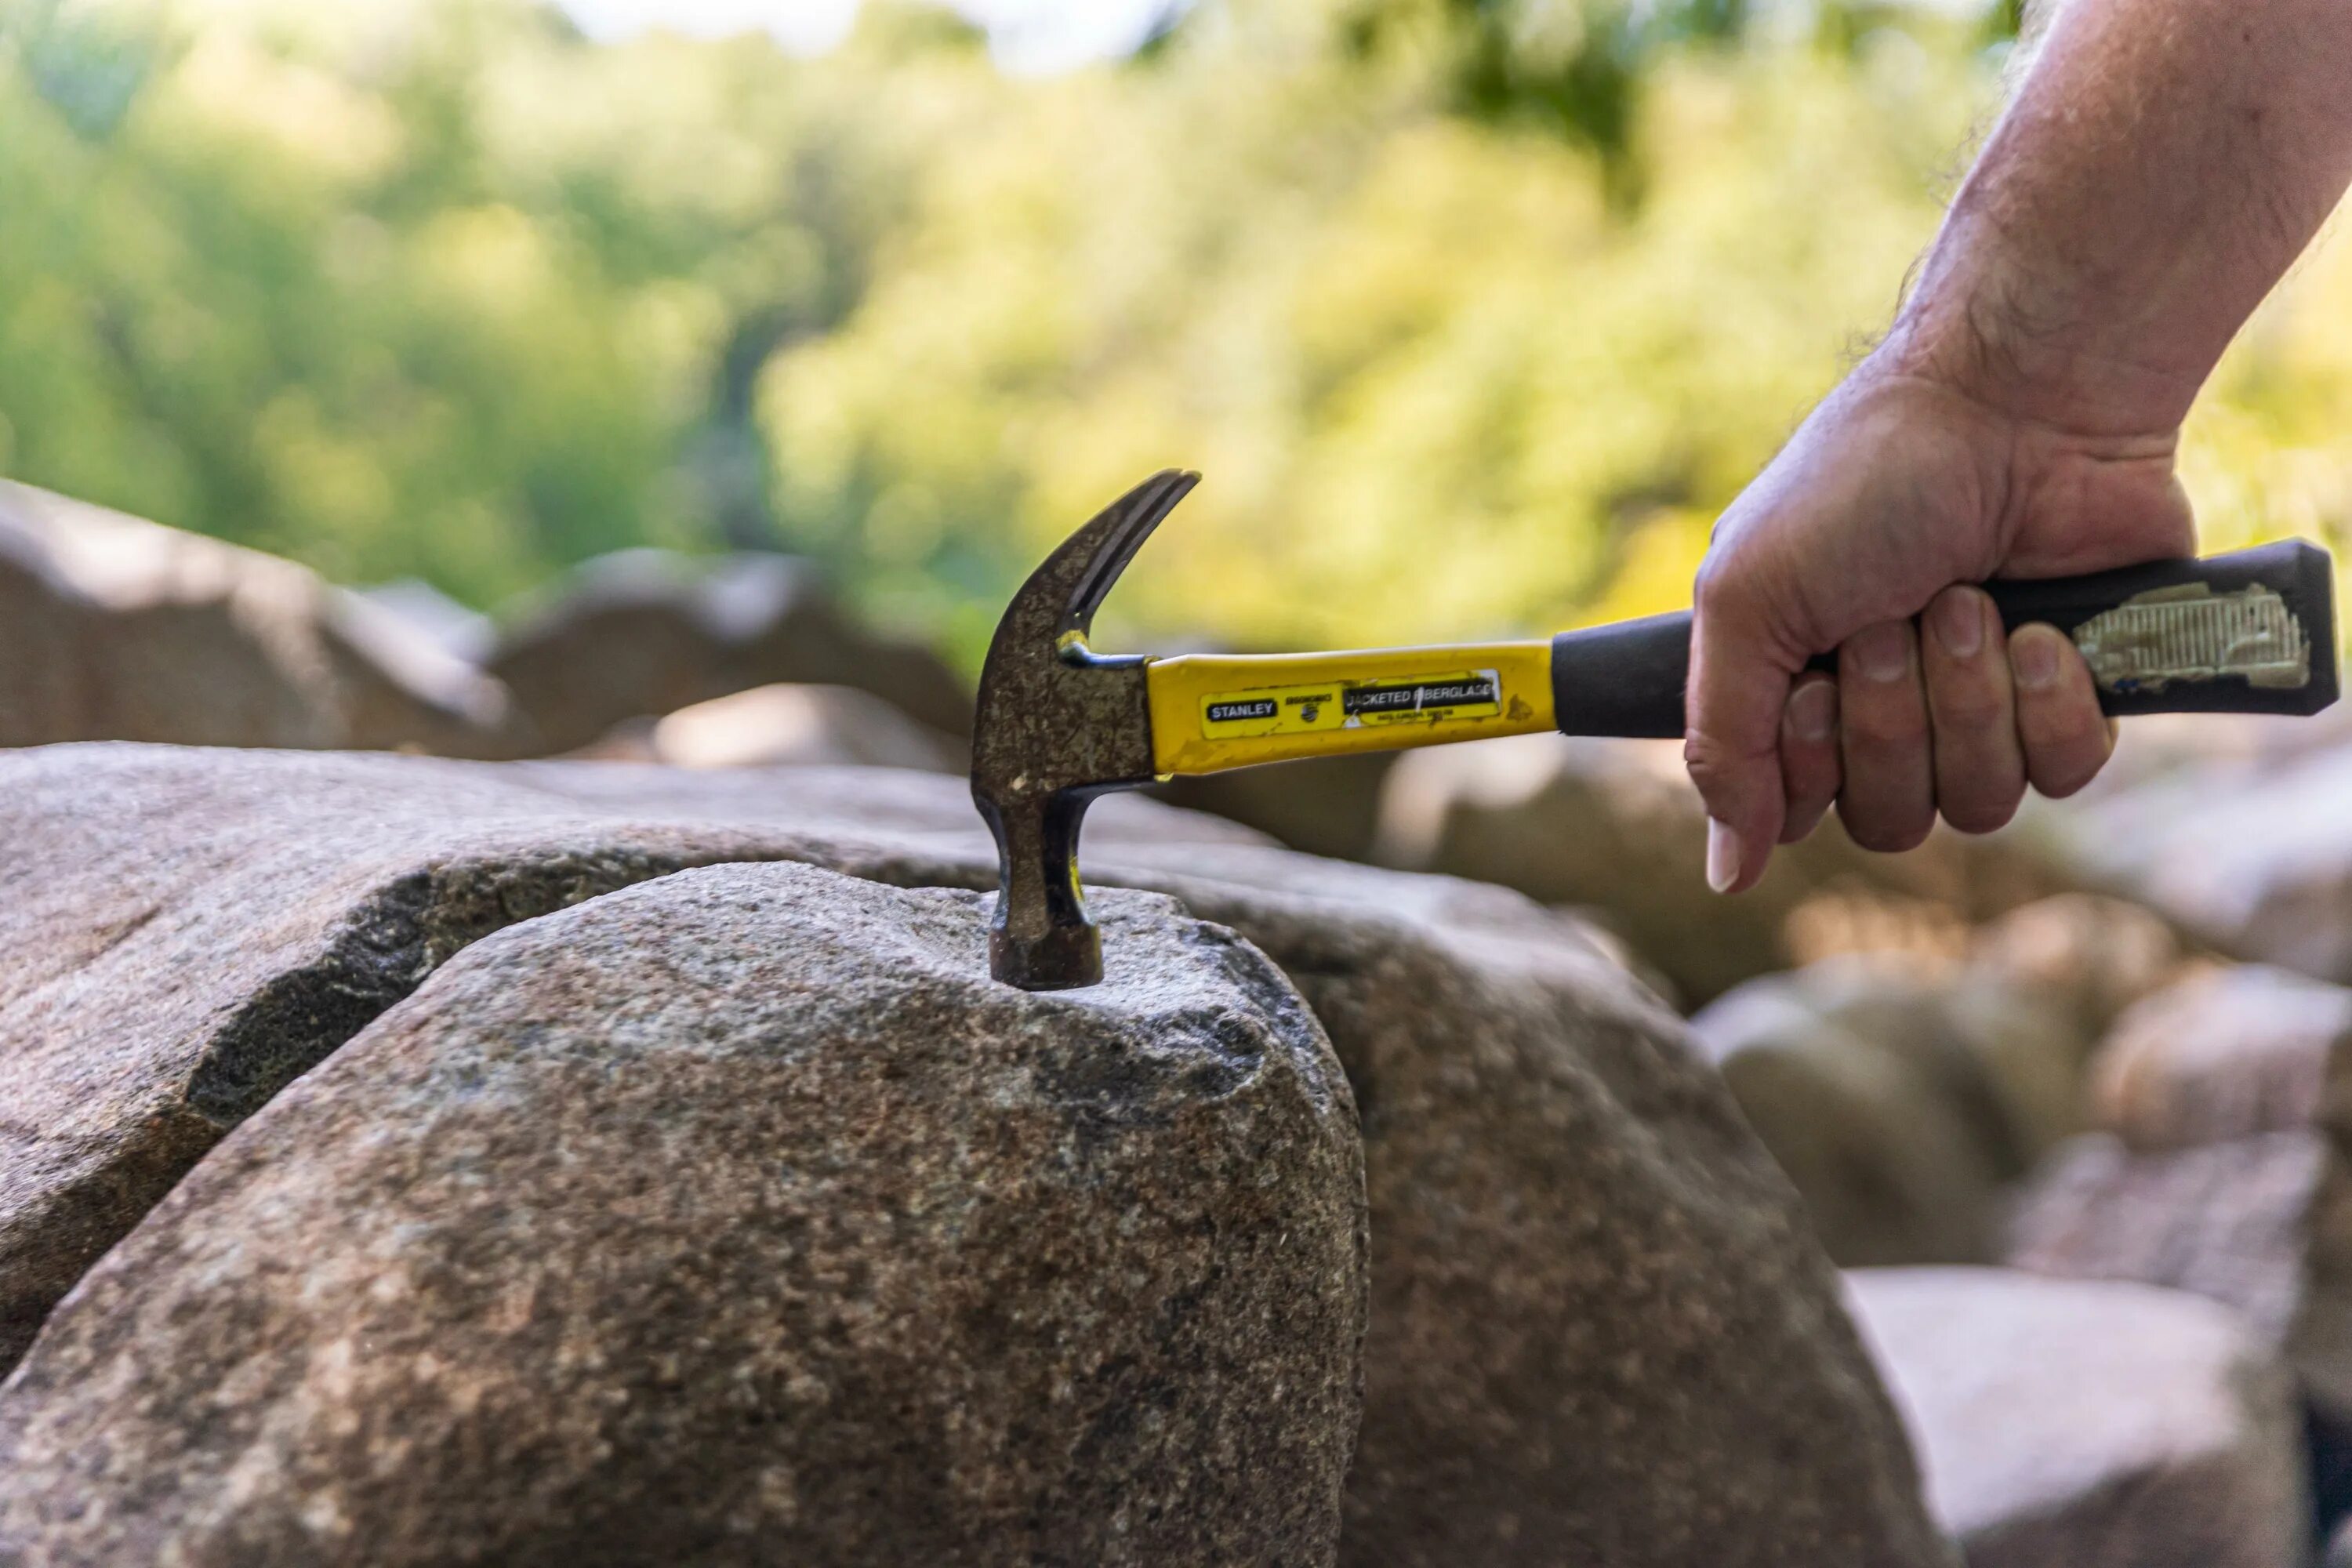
[1884,0,2352,435]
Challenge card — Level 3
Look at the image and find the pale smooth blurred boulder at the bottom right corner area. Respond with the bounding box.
[1846,1269,2310,1568]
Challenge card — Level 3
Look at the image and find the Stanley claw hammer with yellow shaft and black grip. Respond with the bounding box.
[971,470,2336,989]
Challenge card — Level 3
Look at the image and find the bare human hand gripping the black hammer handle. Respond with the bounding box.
[1684,353,2194,891]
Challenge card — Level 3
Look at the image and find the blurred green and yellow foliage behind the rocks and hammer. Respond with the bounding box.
[0,0,2352,668]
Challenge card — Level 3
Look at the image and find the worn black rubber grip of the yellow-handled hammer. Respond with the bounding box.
[1552,539,2336,739]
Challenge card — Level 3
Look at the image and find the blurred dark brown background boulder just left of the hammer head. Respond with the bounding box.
[489,550,971,753]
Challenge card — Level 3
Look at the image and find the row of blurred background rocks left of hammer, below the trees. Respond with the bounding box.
[0,482,971,769]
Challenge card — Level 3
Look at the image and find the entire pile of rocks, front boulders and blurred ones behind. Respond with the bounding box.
[13,487,2352,1568]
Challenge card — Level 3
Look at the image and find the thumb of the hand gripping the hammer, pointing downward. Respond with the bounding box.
[1682,583,1795,893]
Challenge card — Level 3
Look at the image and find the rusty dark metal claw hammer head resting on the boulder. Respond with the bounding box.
[971,468,1200,989]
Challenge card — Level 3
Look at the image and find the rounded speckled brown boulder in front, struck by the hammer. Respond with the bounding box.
[0,865,1364,1568]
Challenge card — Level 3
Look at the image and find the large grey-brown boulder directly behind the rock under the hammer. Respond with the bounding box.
[0,748,1943,1568]
